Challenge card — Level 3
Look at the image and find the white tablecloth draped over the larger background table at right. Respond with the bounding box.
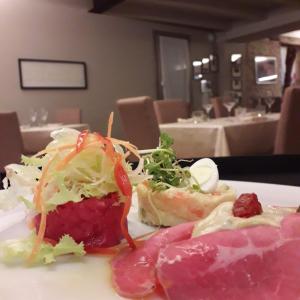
[159,114,280,158]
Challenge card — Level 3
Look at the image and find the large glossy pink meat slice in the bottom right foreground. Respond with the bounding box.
[156,214,300,300]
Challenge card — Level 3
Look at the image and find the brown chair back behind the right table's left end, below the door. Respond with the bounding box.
[154,99,190,124]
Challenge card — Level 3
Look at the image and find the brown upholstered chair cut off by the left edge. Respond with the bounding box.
[0,112,23,173]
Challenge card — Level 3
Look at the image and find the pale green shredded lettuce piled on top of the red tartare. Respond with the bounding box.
[42,148,118,211]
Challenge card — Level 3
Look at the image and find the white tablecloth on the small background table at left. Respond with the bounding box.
[21,124,89,155]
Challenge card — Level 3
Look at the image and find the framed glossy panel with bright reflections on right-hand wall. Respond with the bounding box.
[254,56,278,84]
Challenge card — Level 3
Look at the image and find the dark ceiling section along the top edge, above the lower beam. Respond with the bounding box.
[92,0,300,31]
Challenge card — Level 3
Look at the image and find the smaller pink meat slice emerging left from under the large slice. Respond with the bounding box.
[112,223,194,298]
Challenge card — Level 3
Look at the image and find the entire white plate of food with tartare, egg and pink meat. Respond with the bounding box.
[0,113,300,300]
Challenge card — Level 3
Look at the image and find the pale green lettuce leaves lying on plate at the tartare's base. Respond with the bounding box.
[0,234,85,264]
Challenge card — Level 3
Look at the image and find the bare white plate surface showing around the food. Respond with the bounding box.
[0,181,300,300]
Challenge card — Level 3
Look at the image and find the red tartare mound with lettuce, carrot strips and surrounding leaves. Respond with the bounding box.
[0,114,149,264]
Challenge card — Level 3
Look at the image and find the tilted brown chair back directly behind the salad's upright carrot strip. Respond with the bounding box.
[117,96,159,149]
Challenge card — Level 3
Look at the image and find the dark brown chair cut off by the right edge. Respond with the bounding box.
[274,87,300,154]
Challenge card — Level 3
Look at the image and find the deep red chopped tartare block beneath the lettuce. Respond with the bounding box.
[34,193,124,252]
